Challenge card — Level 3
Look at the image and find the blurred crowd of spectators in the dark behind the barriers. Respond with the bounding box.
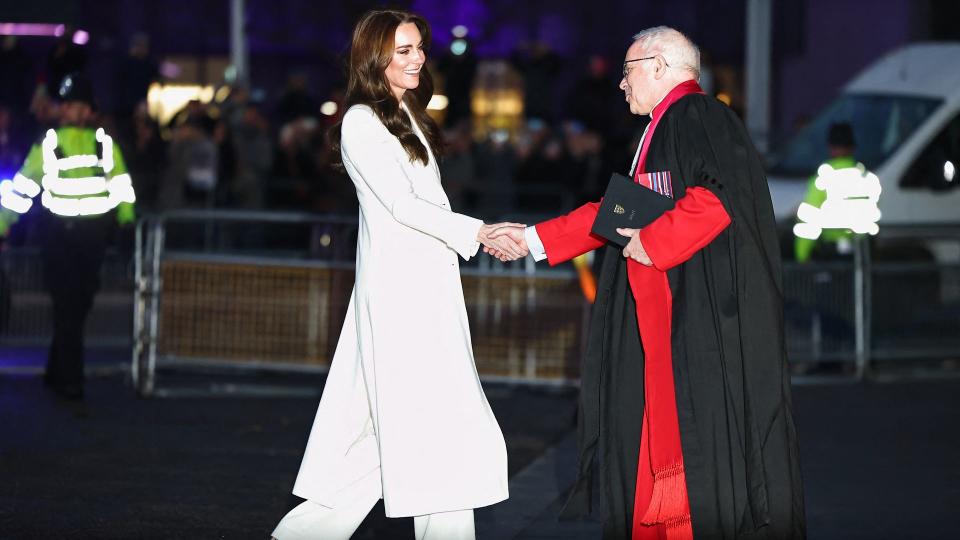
[0,32,642,226]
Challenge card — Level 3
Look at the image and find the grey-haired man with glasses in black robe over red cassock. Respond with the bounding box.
[488,27,806,540]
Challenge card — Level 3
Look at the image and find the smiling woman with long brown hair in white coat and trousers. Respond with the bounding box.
[273,11,526,540]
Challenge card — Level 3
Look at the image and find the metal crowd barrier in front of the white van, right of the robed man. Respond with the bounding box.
[784,227,960,379]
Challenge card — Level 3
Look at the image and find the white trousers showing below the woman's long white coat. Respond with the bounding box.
[273,468,476,540]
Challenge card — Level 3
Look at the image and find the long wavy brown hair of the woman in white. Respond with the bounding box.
[329,10,443,166]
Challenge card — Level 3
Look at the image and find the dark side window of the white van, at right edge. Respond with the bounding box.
[900,115,960,191]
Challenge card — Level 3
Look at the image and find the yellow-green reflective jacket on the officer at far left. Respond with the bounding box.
[0,126,136,221]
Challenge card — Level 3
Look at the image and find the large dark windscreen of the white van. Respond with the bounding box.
[770,94,943,177]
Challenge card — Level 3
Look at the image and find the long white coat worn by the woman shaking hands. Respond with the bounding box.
[293,105,507,517]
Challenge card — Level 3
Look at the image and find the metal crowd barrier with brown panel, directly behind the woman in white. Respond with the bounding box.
[132,211,589,395]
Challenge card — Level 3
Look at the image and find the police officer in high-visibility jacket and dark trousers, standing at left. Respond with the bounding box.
[0,73,136,399]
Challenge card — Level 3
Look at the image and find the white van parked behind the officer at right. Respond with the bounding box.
[767,43,960,228]
